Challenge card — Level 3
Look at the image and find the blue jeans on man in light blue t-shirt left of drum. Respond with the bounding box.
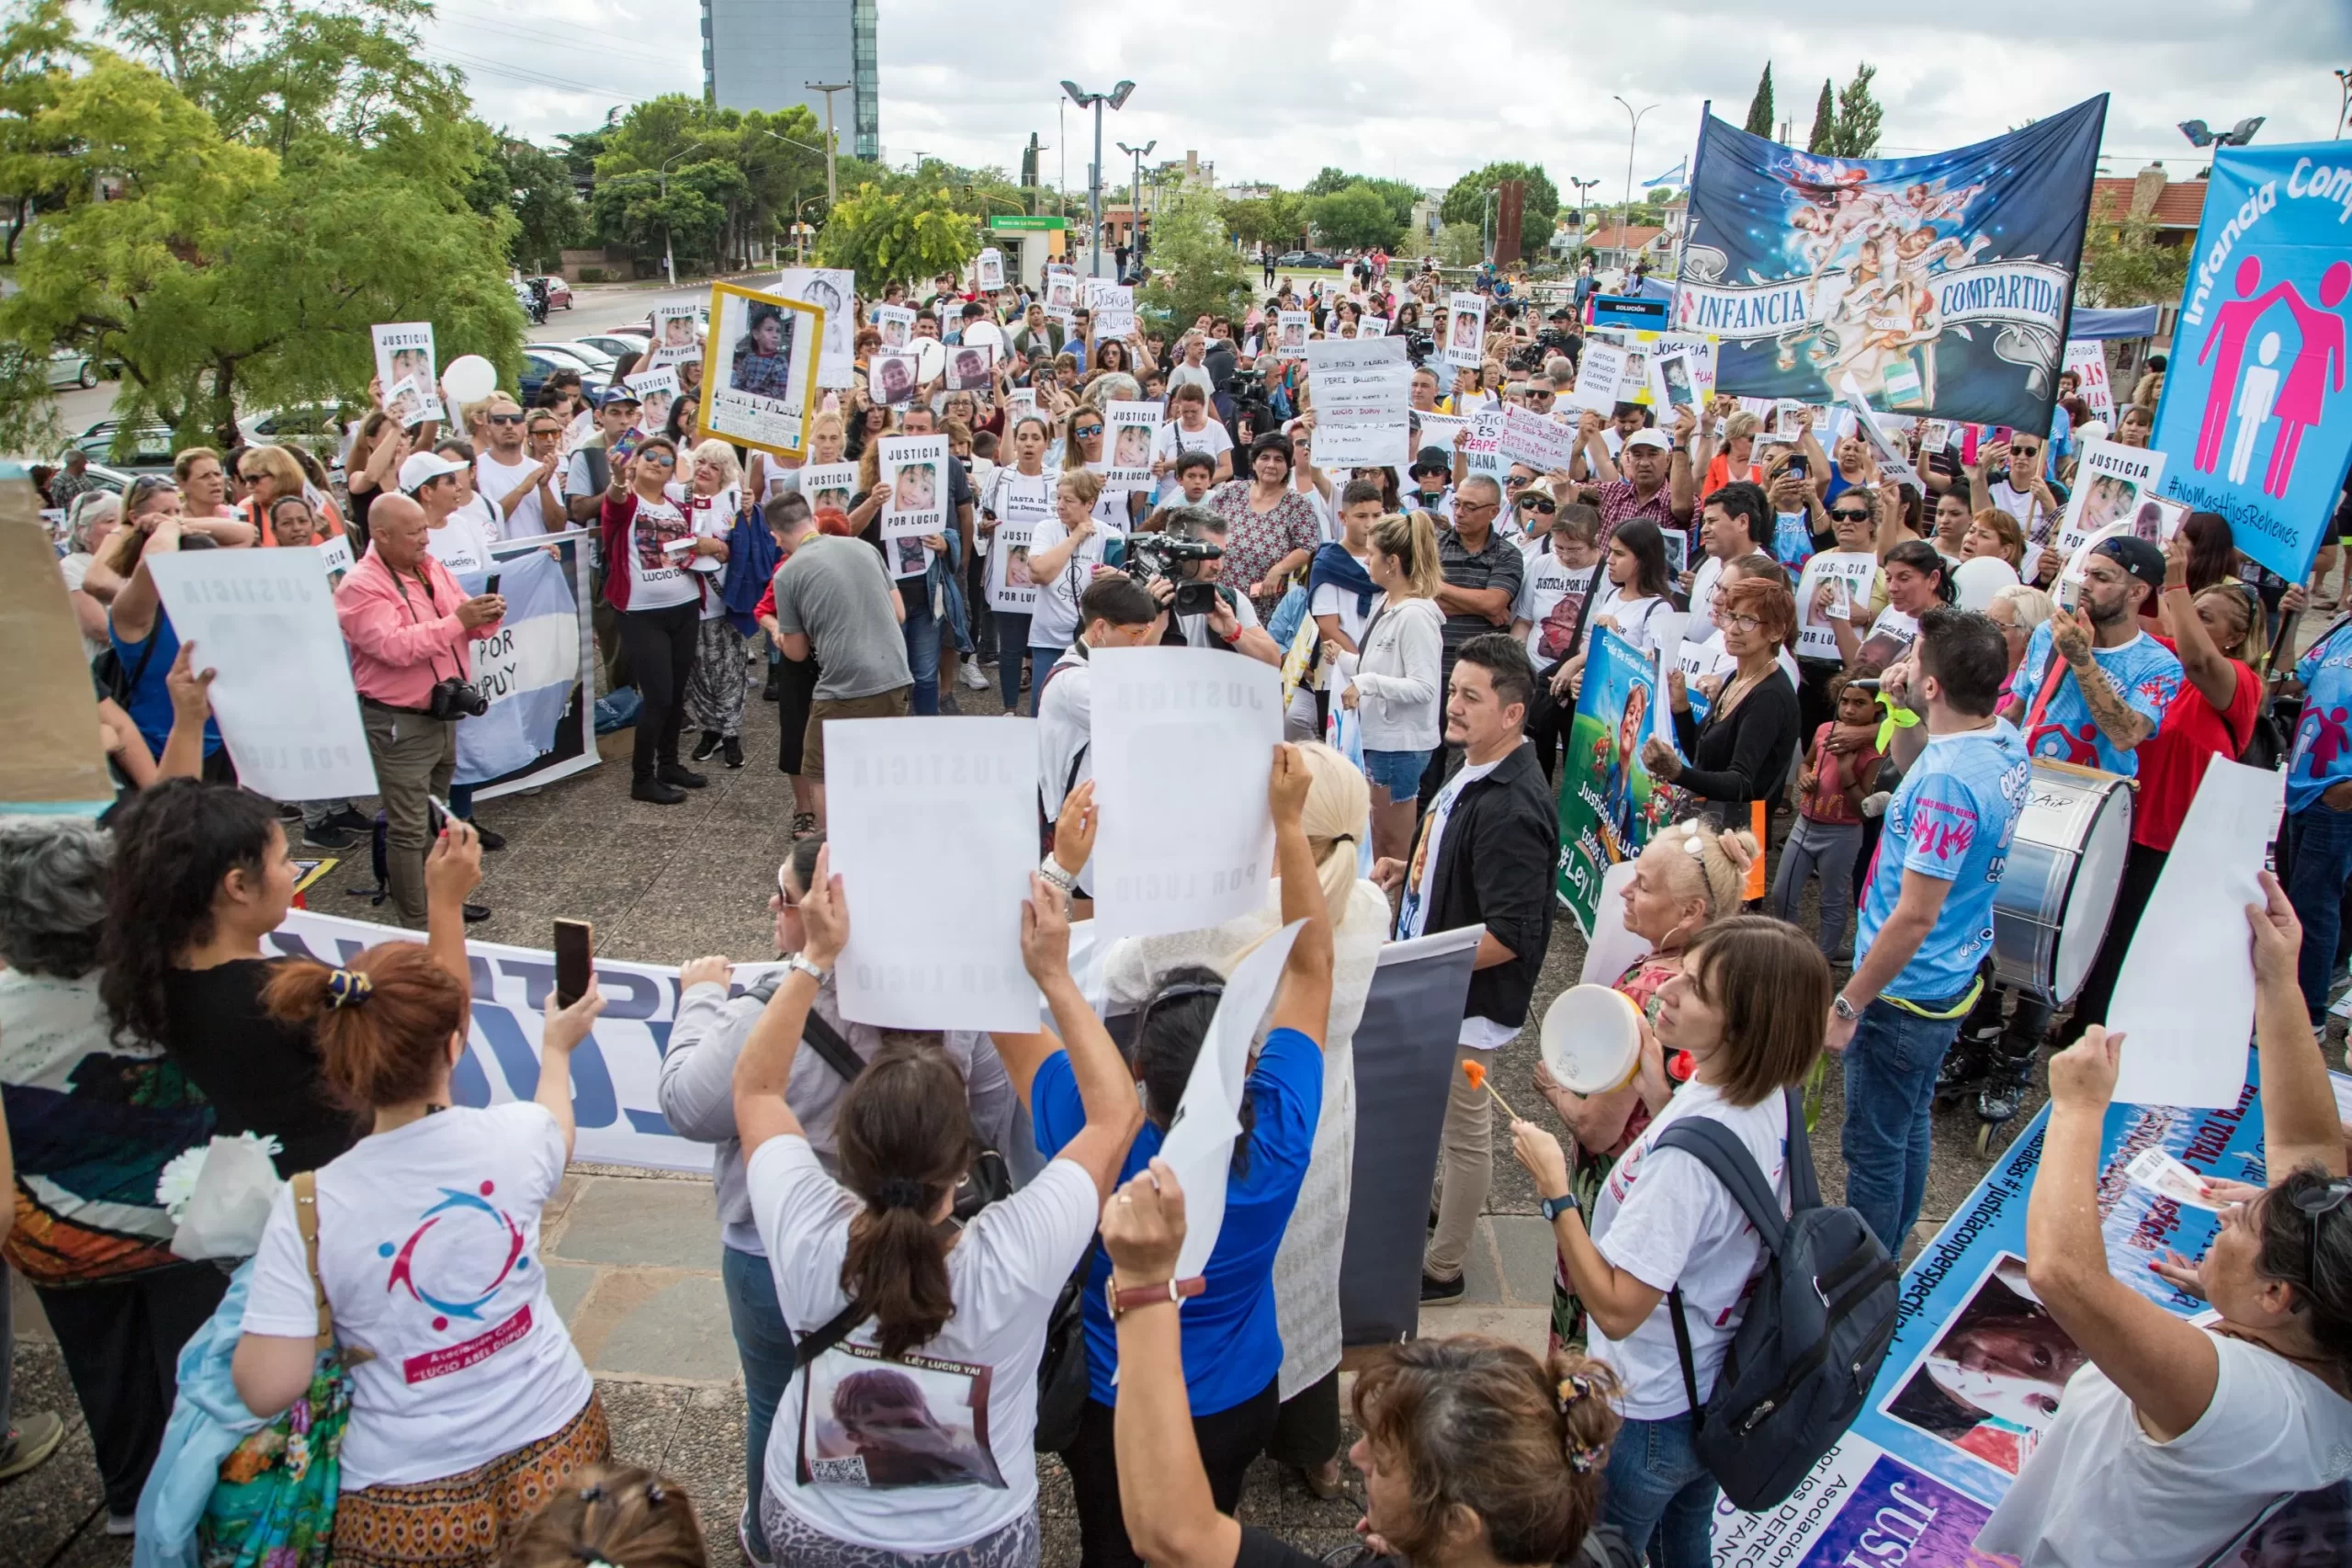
[1837,997,1959,1258]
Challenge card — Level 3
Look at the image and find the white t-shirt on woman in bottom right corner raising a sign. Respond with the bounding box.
[1975,1336,2352,1568]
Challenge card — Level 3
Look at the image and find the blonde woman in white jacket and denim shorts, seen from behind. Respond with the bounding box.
[1339,510,1446,861]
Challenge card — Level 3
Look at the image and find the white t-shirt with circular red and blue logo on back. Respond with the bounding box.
[243,1105,595,1493]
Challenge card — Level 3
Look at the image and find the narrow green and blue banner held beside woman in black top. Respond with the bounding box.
[1555,627,1670,936]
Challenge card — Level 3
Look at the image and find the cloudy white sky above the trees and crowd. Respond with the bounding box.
[428,0,2352,200]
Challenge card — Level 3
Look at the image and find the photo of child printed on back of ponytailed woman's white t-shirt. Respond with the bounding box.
[799,1344,1004,1491]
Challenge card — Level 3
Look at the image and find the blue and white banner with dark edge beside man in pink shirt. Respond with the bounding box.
[457,529,597,799]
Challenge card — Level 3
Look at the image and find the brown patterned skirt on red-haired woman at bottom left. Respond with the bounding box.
[334,1394,612,1568]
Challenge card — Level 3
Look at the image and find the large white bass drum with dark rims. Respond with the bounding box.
[1992,757,2131,1006]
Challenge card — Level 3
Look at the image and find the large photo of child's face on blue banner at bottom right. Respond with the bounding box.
[1886,1253,2088,1474]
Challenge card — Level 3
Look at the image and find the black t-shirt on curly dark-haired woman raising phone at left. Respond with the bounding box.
[164,959,367,1176]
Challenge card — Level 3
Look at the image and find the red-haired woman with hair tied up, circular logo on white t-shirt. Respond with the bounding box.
[235,942,612,1568]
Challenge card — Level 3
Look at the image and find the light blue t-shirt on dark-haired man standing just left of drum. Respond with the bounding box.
[1853,719,2032,1001]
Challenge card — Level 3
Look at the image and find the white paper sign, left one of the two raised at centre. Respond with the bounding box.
[826,717,1040,1030]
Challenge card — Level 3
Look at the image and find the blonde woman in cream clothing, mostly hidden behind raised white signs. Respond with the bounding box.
[1086,743,1387,1497]
